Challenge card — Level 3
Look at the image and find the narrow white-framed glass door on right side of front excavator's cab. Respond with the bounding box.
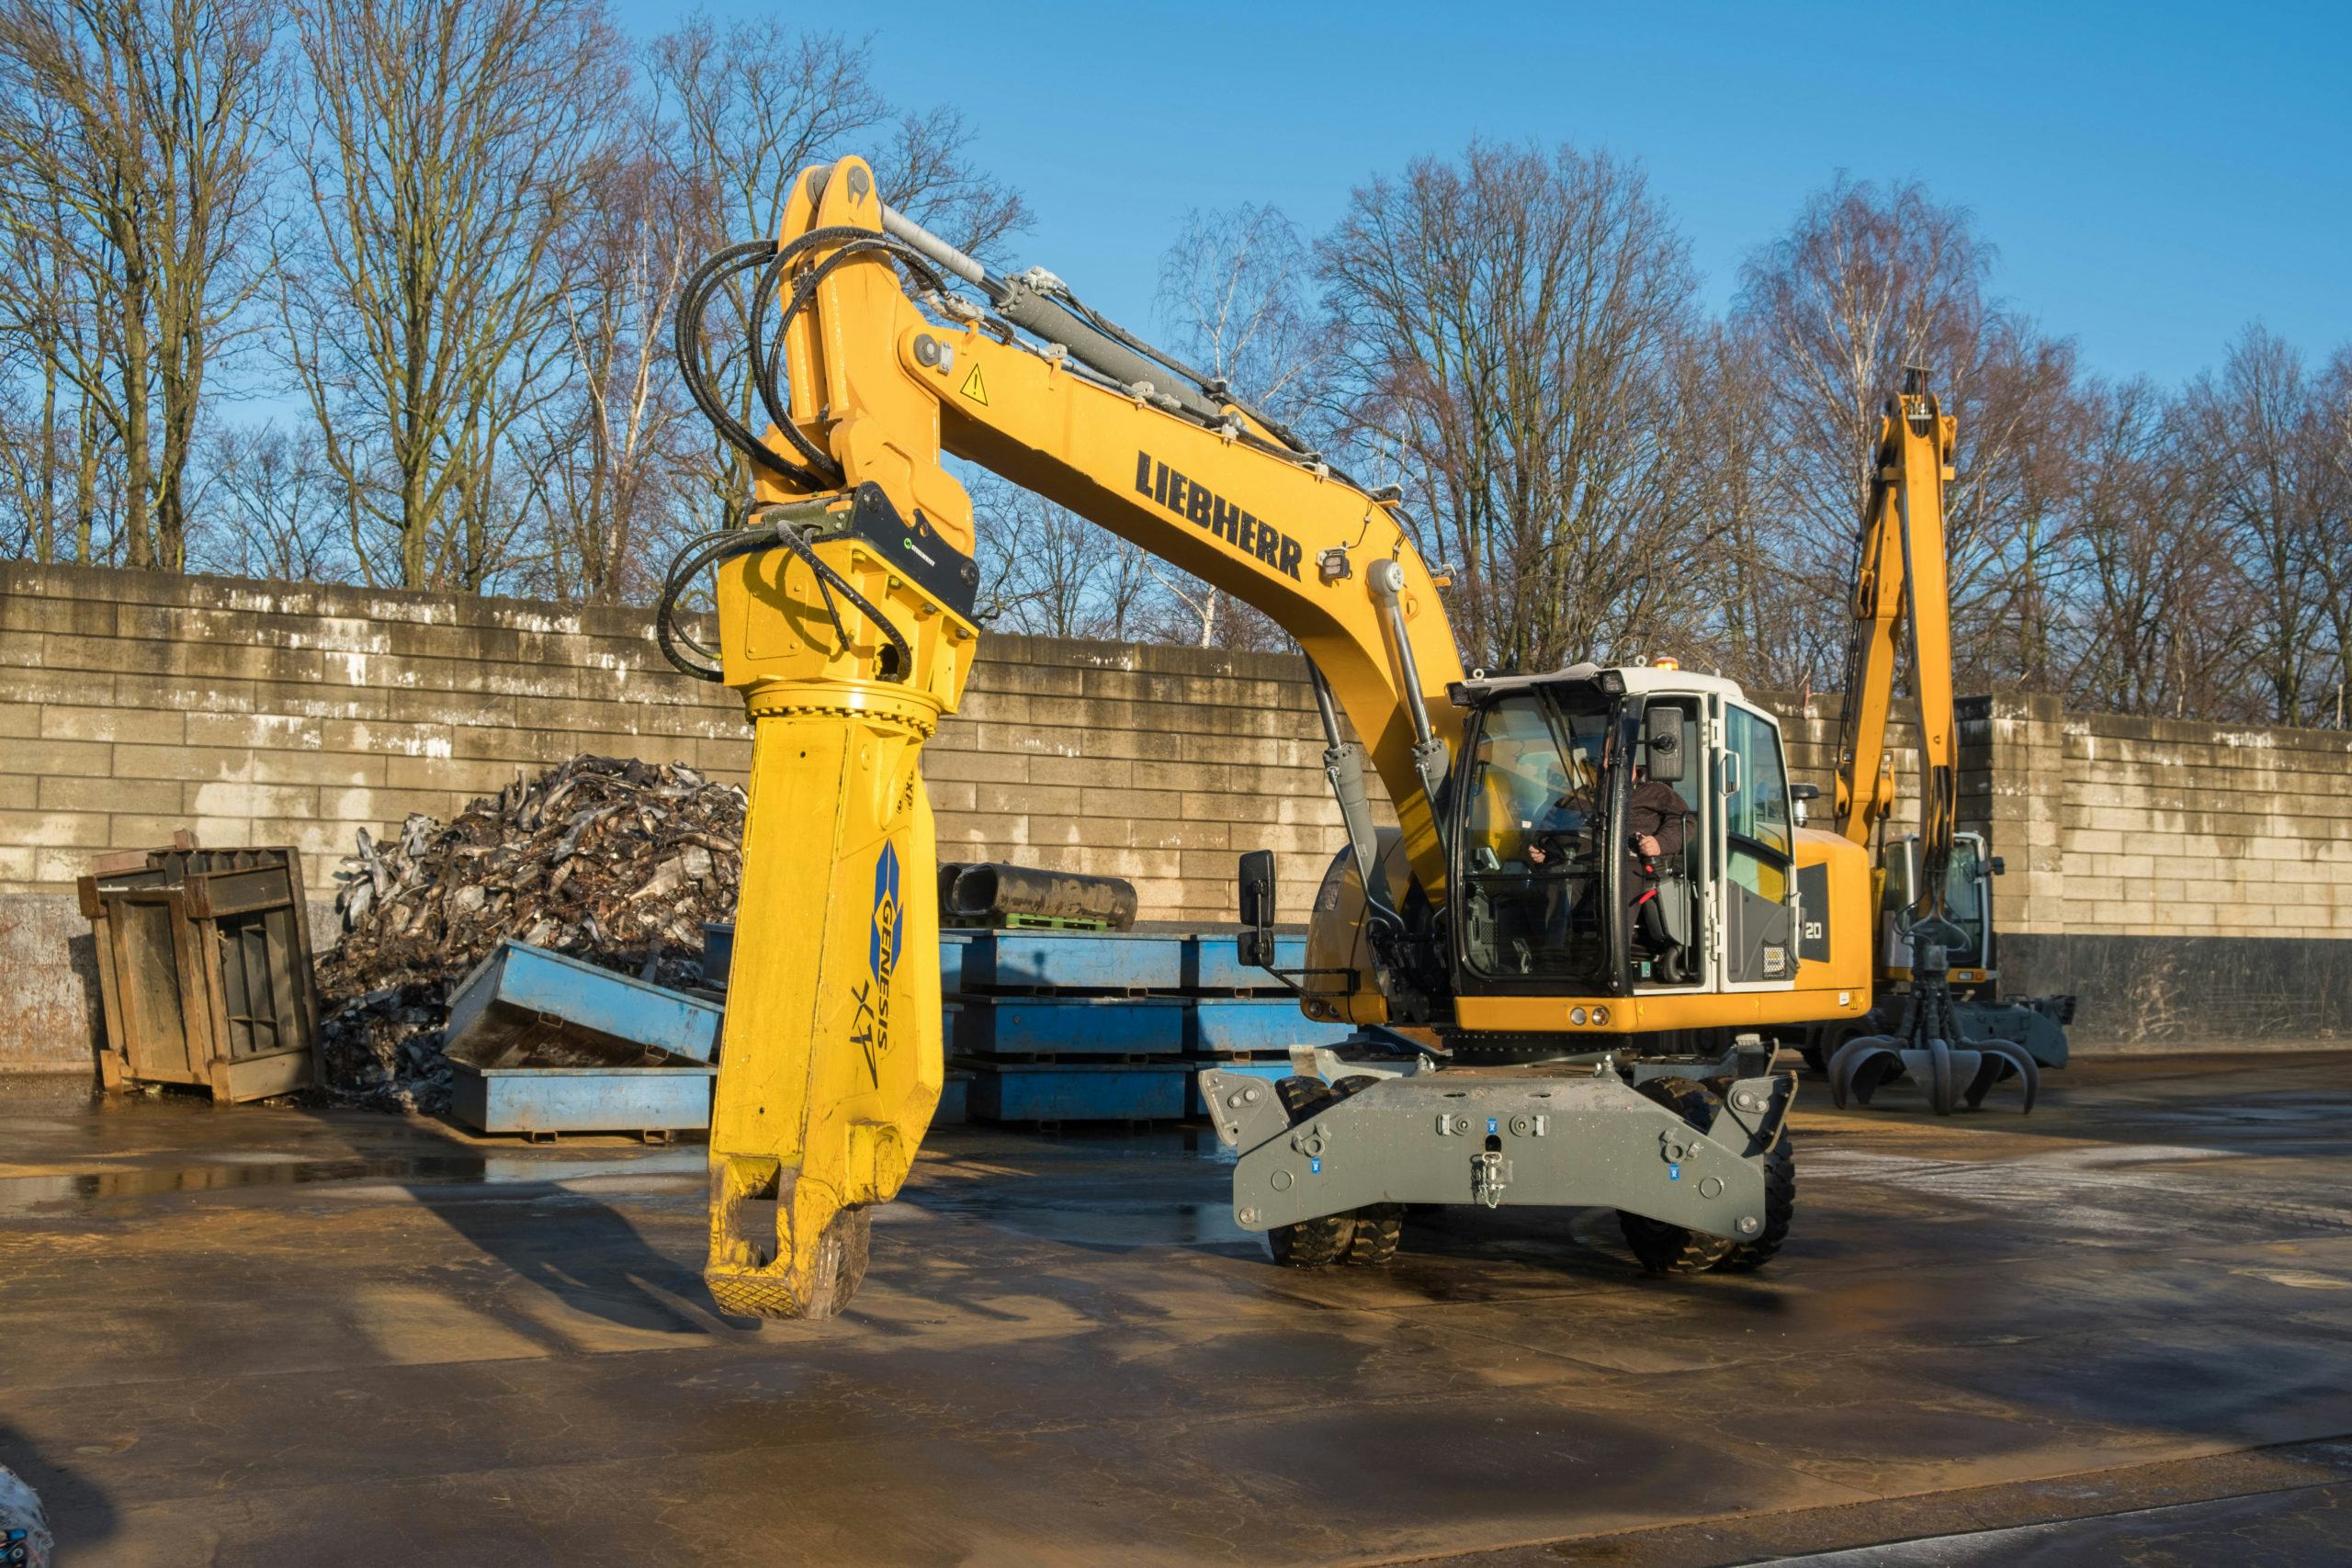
[1714,703,1797,992]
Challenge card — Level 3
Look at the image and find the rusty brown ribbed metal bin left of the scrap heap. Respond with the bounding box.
[80,846,318,1102]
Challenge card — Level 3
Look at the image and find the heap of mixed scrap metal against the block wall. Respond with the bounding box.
[318,755,743,1112]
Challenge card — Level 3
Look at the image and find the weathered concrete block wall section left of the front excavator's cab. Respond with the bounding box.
[0,564,1385,1069]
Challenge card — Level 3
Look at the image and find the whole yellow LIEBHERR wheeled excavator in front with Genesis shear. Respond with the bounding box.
[659,157,2041,1316]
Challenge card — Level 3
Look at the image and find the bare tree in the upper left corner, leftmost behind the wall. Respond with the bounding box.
[0,0,277,571]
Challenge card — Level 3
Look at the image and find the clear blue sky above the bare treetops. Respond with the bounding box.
[618,0,2352,381]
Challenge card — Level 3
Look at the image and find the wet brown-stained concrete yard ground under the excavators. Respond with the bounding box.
[0,1054,2352,1568]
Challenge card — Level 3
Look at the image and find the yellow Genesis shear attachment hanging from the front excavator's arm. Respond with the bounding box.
[703,510,974,1316]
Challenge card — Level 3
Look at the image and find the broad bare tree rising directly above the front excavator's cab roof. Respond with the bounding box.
[1319,143,1724,668]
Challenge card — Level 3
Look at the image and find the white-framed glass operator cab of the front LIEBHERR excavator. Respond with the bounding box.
[1449,665,1797,997]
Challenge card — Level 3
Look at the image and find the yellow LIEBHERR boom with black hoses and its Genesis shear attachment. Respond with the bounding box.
[682,157,1463,1316]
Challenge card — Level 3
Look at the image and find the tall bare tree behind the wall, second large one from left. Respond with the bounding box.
[277,0,626,588]
